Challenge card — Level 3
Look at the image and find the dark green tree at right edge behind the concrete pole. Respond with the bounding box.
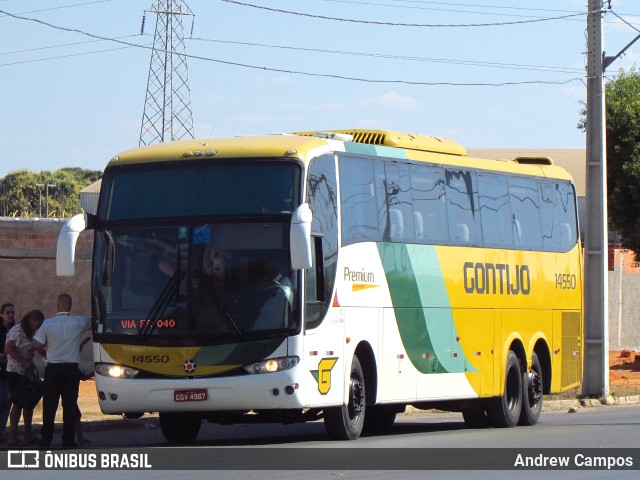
[578,69,640,260]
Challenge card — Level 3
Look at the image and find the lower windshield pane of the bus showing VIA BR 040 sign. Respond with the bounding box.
[93,222,299,343]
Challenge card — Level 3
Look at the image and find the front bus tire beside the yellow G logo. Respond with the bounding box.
[324,356,366,440]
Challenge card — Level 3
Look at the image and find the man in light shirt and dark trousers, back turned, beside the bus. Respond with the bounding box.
[33,293,91,448]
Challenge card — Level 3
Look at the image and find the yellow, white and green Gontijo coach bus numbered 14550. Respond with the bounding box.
[58,130,582,442]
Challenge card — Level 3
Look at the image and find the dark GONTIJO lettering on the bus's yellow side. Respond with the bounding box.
[463,262,531,295]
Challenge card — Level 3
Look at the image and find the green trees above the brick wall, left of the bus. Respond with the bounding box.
[0,167,102,217]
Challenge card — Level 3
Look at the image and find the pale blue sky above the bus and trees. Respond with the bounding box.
[0,0,640,177]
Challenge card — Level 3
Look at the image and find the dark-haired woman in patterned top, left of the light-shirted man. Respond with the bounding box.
[5,310,44,445]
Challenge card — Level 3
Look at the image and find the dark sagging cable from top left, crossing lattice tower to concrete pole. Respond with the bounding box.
[0,10,582,87]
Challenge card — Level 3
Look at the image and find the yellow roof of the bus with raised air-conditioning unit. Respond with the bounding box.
[108,129,572,180]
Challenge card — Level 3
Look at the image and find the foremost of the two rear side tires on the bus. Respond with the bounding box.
[489,350,522,428]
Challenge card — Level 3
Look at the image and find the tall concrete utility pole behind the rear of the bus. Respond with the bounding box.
[584,0,609,398]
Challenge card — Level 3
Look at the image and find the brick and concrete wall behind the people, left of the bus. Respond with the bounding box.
[0,217,93,320]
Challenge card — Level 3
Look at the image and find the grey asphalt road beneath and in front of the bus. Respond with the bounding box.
[5,405,640,480]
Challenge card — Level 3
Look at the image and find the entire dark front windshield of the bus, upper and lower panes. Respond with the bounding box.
[93,159,301,343]
